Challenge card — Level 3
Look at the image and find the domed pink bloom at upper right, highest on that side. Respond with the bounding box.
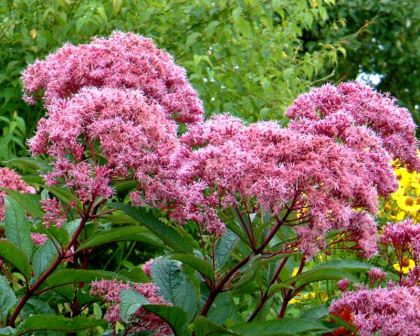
[286,82,420,169]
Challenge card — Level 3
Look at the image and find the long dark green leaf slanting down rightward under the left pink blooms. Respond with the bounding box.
[111,203,193,252]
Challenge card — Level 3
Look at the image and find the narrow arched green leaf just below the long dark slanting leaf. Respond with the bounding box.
[78,226,163,251]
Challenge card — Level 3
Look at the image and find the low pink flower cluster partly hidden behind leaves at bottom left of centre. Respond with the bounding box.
[91,280,173,336]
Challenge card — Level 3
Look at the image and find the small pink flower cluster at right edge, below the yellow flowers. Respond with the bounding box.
[380,219,420,262]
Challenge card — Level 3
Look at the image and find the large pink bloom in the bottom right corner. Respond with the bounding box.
[330,286,420,336]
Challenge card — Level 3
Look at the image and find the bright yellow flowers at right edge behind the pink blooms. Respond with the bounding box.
[379,162,420,223]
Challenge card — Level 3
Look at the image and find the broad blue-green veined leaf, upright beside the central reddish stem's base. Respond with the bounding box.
[151,259,197,317]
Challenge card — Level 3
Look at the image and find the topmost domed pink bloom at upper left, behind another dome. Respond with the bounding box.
[22,32,203,122]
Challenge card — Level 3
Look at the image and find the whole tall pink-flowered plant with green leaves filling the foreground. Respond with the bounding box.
[0,33,420,336]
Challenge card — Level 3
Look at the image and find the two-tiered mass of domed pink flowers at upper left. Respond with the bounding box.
[23,33,203,202]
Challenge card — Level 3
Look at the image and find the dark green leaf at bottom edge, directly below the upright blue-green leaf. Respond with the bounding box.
[143,305,190,336]
